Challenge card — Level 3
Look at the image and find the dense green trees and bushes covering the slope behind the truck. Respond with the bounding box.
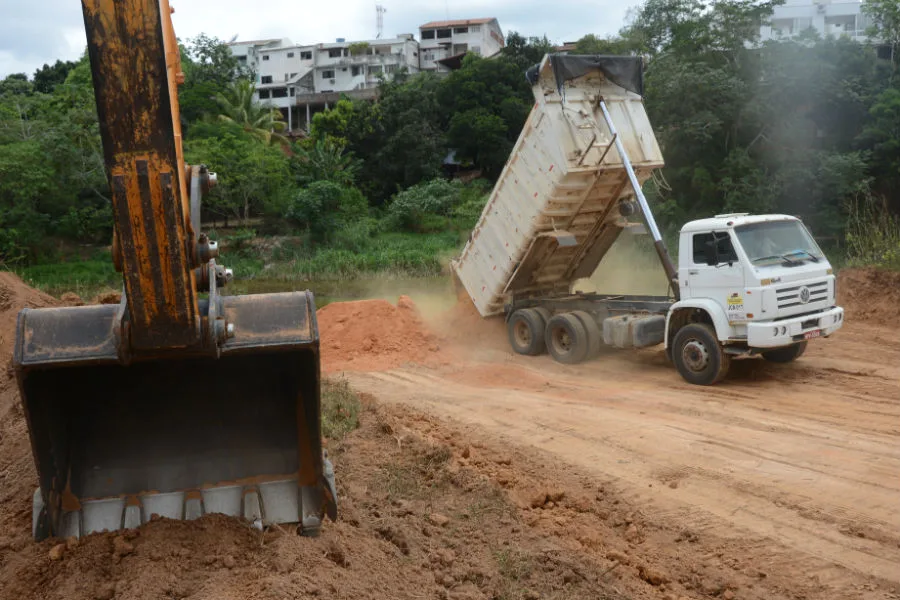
[0,0,900,298]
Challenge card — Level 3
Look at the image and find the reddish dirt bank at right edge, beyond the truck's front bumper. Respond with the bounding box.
[837,267,900,325]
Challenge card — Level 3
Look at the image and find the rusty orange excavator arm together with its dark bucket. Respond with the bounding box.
[13,0,337,539]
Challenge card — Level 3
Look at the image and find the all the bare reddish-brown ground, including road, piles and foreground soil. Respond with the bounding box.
[0,270,900,600]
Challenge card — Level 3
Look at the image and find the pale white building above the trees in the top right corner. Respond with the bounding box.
[760,0,871,42]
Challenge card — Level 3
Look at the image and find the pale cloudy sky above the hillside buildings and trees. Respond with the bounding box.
[0,0,638,78]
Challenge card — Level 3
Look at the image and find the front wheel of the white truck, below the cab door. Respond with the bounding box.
[672,323,731,385]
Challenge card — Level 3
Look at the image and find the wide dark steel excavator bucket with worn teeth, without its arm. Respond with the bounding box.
[14,292,336,538]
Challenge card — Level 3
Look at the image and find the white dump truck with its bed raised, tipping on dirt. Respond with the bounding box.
[451,54,844,385]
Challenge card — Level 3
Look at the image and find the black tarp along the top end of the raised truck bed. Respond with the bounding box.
[525,54,644,96]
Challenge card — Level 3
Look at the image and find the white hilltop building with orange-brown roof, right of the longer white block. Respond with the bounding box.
[419,18,506,72]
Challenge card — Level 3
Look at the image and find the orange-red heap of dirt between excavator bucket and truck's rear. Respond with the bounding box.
[316,296,440,373]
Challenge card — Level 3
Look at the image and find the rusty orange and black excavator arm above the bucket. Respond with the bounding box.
[82,0,230,353]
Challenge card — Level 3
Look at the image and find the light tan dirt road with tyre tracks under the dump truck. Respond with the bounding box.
[348,323,900,598]
